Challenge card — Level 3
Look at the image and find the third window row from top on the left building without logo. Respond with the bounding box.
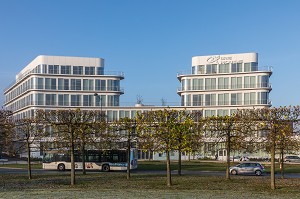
[7,93,120,111]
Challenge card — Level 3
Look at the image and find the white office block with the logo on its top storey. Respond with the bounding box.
[177,53,272,116]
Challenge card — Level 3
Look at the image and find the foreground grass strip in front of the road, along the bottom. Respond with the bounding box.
[0,172,300,199]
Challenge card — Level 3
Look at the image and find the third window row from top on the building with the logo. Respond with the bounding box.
[181,92,269,106]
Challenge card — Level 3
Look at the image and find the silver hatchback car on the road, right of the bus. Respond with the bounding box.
[229,162,265,176]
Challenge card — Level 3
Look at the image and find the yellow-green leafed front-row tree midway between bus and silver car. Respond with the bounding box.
[137,109,199,187]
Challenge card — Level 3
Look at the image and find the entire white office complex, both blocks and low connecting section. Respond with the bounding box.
[4,53,272,159]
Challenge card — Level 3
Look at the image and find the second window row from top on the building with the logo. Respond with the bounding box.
[180,75,270,91]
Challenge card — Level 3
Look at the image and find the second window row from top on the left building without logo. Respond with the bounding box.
[5,77,121,102]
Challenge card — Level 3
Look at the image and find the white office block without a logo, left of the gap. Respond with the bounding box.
[4,56,124,119]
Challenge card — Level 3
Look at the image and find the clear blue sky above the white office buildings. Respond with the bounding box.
[0,0,300,106]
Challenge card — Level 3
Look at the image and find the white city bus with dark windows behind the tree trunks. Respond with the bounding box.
[43,148,137,172]
